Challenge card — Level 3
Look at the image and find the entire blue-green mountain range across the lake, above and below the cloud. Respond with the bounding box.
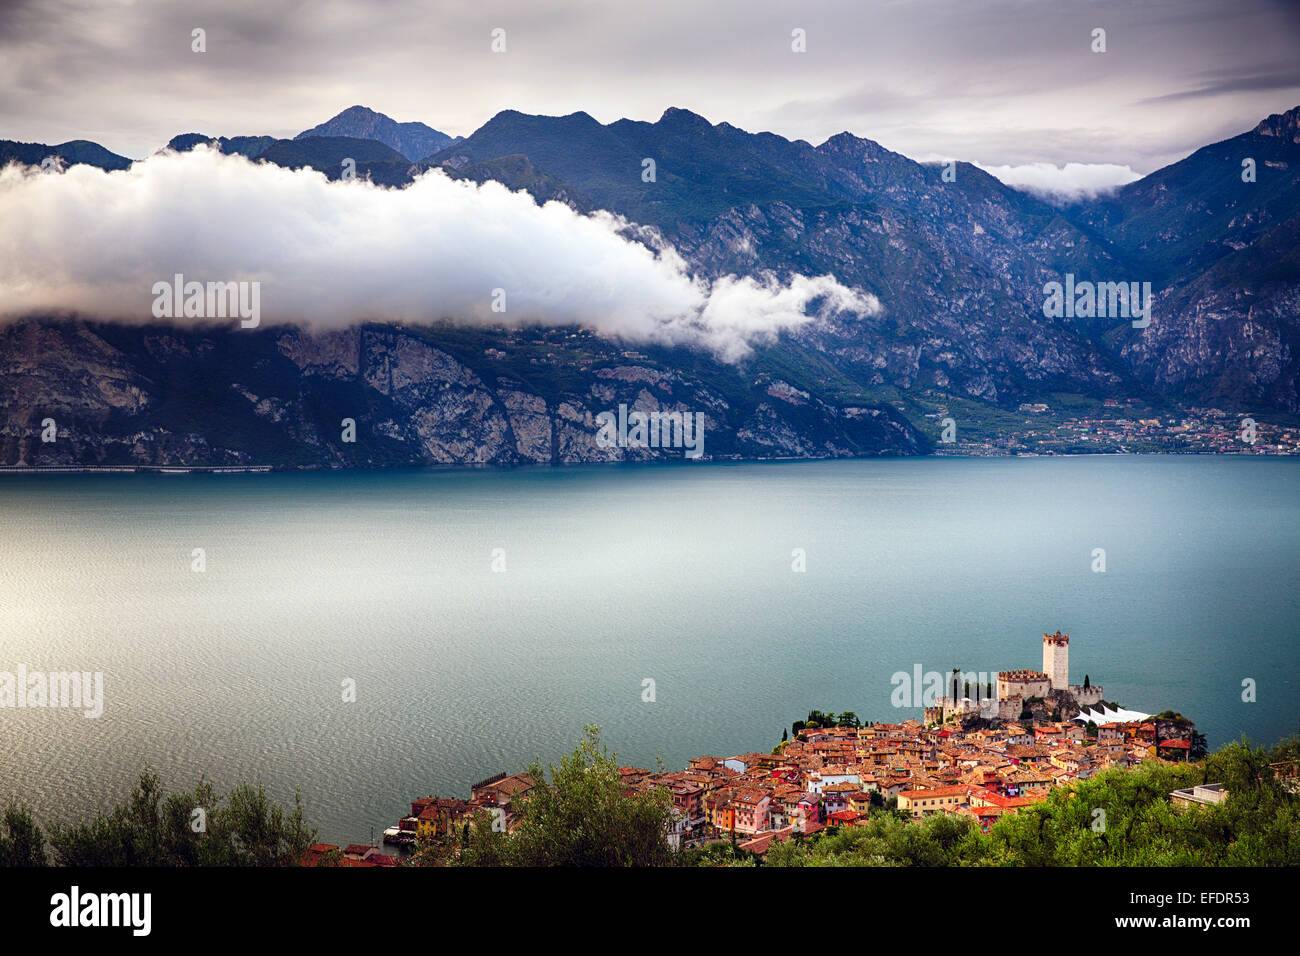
[0,100,1300,466]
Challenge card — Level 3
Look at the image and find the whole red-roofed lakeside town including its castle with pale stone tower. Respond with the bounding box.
[304,631,1201,866]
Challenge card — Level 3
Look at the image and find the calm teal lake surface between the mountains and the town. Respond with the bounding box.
[0,457,1300,843]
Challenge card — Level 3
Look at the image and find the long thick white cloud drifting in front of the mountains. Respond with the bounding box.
[0,147,879,360]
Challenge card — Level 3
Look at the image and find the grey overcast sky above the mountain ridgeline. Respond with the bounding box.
[0,0,1300,181]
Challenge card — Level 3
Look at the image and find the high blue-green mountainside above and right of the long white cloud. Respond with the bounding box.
[421,108,1300,415]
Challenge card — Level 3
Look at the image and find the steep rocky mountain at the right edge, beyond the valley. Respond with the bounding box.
[1073,107,1300,414]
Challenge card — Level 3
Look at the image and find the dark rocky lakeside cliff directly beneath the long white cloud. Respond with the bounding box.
[0,321,931,467]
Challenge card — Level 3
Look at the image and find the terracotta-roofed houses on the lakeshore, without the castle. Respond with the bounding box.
[304,718,1187,866]
